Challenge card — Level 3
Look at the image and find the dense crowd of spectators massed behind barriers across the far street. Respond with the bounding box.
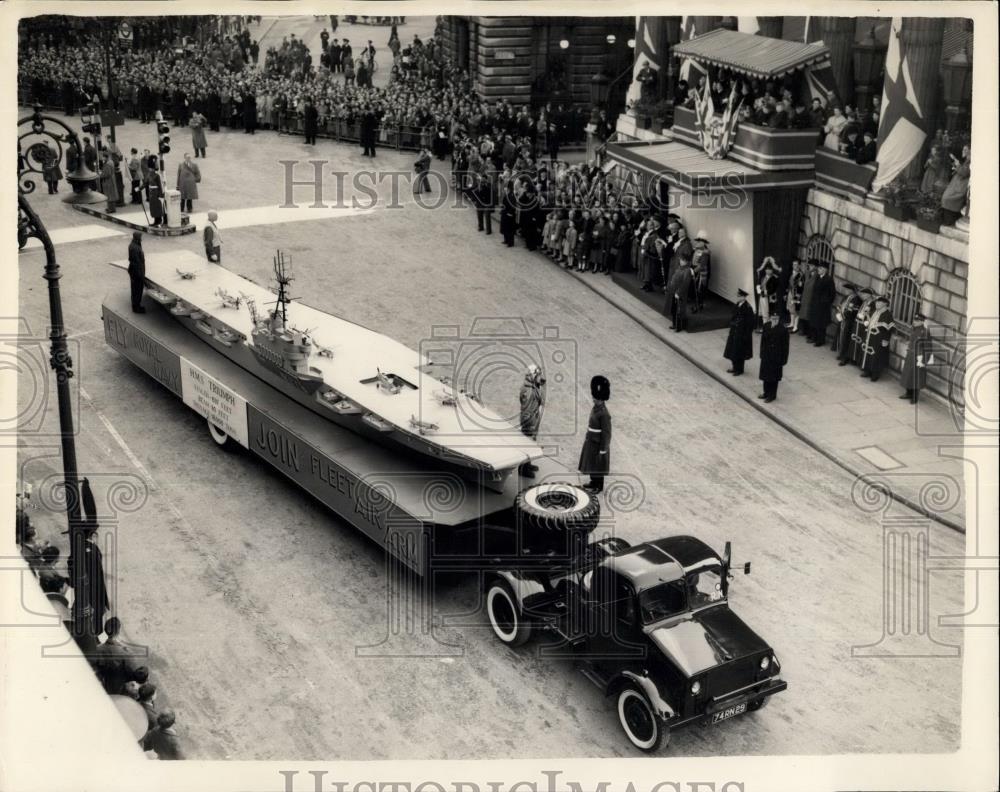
[19,17,587,156]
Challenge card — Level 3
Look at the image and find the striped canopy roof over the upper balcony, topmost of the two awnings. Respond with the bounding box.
[673,28,830,78]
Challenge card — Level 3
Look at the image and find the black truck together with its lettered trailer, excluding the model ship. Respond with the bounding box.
[102,268,786,752]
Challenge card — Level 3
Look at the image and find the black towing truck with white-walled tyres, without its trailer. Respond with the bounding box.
[486,536,787,752]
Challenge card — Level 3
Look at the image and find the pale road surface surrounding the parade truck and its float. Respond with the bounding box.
[11,110,965,760]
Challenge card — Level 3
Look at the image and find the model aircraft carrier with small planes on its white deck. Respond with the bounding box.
[116,251,543,489]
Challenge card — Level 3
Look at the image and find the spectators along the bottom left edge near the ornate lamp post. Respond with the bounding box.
[15,487,182,759]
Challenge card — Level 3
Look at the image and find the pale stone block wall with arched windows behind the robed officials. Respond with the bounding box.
[799,189,969,404]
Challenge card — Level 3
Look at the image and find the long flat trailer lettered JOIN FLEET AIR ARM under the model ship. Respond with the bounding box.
[102,288,599,575]
